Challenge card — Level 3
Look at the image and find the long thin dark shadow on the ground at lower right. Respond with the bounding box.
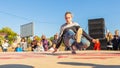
[58,62,120,68]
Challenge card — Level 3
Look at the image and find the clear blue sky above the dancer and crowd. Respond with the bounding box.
[0,0,120,37]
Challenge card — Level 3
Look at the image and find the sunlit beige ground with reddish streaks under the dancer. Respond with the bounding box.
[0,50,120,68]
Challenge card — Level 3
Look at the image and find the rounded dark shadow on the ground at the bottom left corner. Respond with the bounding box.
[0,64,34,68]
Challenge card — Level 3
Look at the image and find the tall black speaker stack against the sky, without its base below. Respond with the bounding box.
[88,18,105,39]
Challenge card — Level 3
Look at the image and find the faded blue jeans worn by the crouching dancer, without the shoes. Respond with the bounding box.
[63,30,90,47]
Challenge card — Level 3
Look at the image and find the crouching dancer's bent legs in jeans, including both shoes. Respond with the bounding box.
[63,28,90,54]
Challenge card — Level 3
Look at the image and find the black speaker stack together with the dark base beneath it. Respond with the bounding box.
[88,18,107,50]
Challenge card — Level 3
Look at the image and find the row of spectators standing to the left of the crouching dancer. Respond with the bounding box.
[0,34,58,52]
